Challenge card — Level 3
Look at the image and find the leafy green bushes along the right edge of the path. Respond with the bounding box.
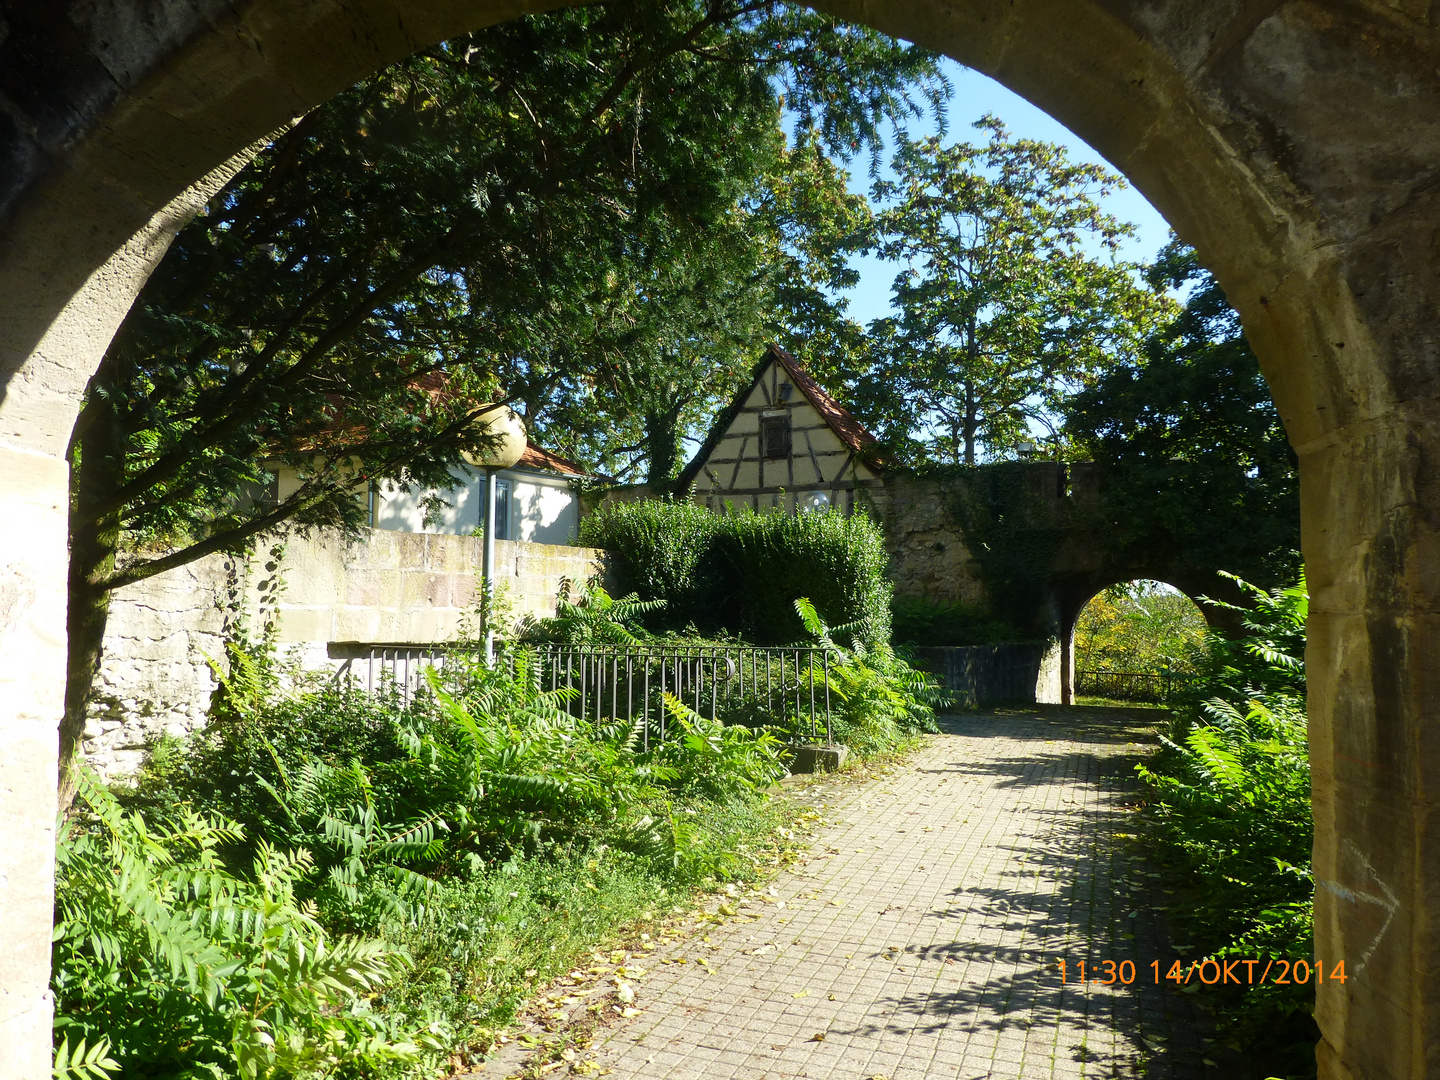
[1139,577,1319,1077]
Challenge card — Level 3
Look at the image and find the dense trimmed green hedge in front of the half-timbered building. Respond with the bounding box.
[580,501,891,644]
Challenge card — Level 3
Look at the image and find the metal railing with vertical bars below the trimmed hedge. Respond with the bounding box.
[334,644,834,749]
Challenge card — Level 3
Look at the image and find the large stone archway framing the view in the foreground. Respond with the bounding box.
[0,0,1440,1077]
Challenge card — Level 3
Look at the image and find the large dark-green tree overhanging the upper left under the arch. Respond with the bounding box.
[62,0,945,806]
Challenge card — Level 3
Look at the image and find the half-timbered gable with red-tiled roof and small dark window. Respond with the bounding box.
[678,346,883,514]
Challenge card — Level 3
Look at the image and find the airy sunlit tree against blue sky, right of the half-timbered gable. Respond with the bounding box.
[854,117,1164,465]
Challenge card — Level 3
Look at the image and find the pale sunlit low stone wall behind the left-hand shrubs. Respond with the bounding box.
[84,528,605,775]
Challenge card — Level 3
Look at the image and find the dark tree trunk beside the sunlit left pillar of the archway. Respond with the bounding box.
[58,395,125,811]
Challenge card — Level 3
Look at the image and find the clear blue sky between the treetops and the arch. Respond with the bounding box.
[845,59,1169,324]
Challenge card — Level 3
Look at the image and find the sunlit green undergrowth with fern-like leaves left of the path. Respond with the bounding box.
[92,651,785,1077]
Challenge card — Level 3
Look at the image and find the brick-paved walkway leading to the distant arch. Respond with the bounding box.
[480,707,1218,1080]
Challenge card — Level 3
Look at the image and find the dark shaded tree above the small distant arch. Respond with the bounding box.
[1066,240,1300,586]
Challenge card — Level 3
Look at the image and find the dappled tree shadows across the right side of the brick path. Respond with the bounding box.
[823,707,1248,1080]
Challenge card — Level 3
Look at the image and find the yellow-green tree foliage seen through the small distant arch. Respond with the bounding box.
[1076,580,1205,674]
